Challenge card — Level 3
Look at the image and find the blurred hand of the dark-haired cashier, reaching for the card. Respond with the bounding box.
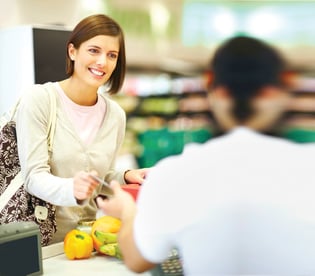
[96,180,136,219]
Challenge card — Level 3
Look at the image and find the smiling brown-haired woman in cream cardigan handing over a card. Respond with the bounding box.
[16,14,147,242]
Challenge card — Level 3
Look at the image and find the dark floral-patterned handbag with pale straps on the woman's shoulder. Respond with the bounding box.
[0,84,57,246]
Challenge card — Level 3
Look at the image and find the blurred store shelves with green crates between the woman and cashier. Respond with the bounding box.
[112,70,213,167]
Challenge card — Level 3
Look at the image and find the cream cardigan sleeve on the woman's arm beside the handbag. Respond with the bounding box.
[16,83,77,206]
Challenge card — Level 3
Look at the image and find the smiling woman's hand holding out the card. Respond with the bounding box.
[73,171,99,201]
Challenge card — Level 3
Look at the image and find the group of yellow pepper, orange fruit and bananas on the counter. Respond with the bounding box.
[64,216,122,260]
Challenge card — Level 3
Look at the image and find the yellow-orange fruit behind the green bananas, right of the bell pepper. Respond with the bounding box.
[91,216,121,252]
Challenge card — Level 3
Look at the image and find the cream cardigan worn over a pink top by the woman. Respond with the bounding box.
[16,83,126,244]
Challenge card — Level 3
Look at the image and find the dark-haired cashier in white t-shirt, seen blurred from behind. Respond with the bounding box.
[98,36,315,276]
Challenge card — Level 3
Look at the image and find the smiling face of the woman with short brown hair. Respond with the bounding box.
[69,35,119,87]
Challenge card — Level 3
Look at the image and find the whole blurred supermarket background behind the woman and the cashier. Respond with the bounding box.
[0,0,315,167]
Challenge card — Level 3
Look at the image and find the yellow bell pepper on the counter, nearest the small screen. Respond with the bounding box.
[63,229,93,260]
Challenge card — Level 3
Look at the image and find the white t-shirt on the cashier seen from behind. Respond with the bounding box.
[135,128,315,276]
